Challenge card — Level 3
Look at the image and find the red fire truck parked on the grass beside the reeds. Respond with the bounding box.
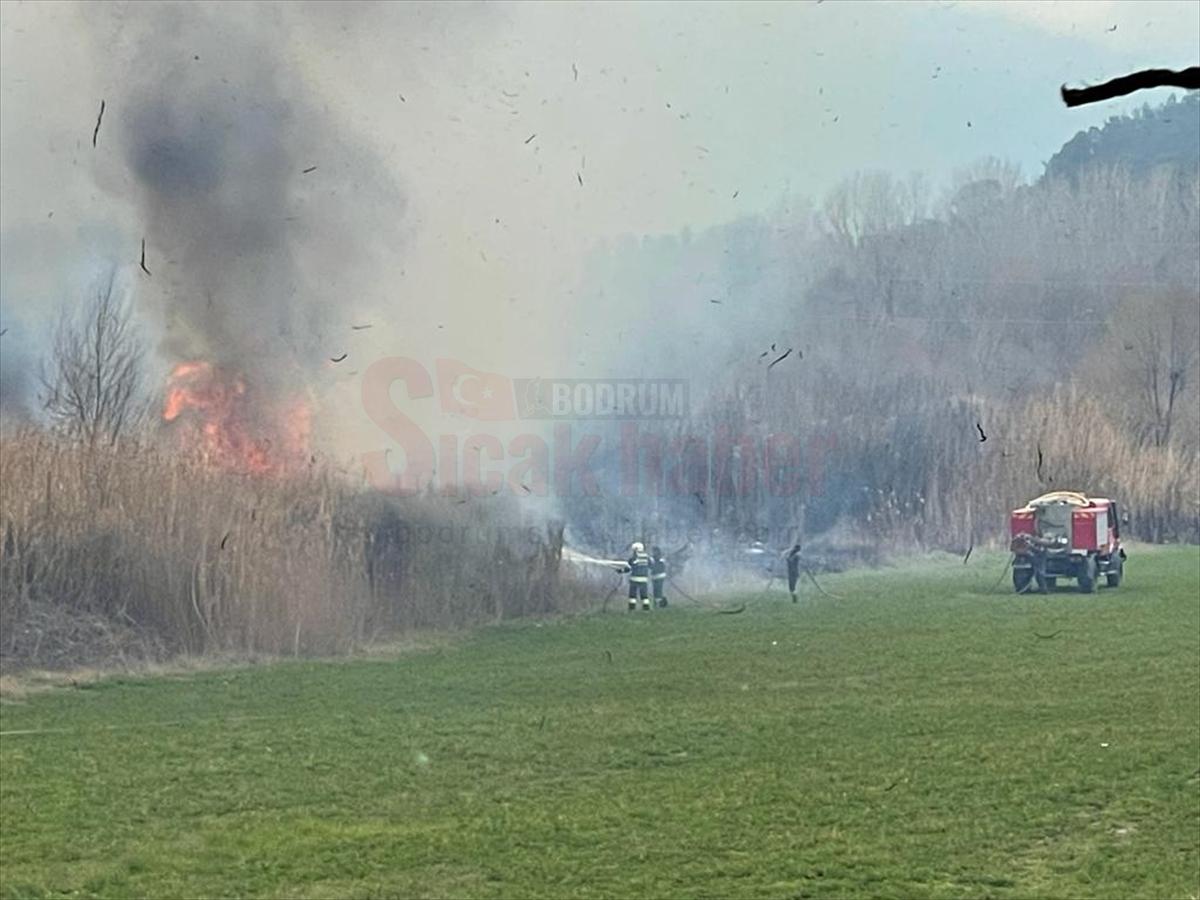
[1009,491,1126,594]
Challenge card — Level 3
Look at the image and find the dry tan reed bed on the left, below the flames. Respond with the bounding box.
[0,431,566,665]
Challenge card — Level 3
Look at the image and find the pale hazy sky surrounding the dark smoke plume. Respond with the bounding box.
[0,0,1200,458]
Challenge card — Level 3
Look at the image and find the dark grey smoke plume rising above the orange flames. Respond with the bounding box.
[100,5,403,405]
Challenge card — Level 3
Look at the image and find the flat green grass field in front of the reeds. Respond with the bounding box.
[0,548,1200,898]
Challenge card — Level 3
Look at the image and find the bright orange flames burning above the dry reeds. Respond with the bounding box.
[162,360,312,474]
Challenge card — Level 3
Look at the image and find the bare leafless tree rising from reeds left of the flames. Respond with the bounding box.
[40,271,146,448]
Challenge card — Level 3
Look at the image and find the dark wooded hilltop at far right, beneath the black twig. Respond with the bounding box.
[1044,91,1200,181]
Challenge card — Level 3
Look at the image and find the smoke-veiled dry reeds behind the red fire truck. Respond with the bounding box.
[688,373,1200,551]
